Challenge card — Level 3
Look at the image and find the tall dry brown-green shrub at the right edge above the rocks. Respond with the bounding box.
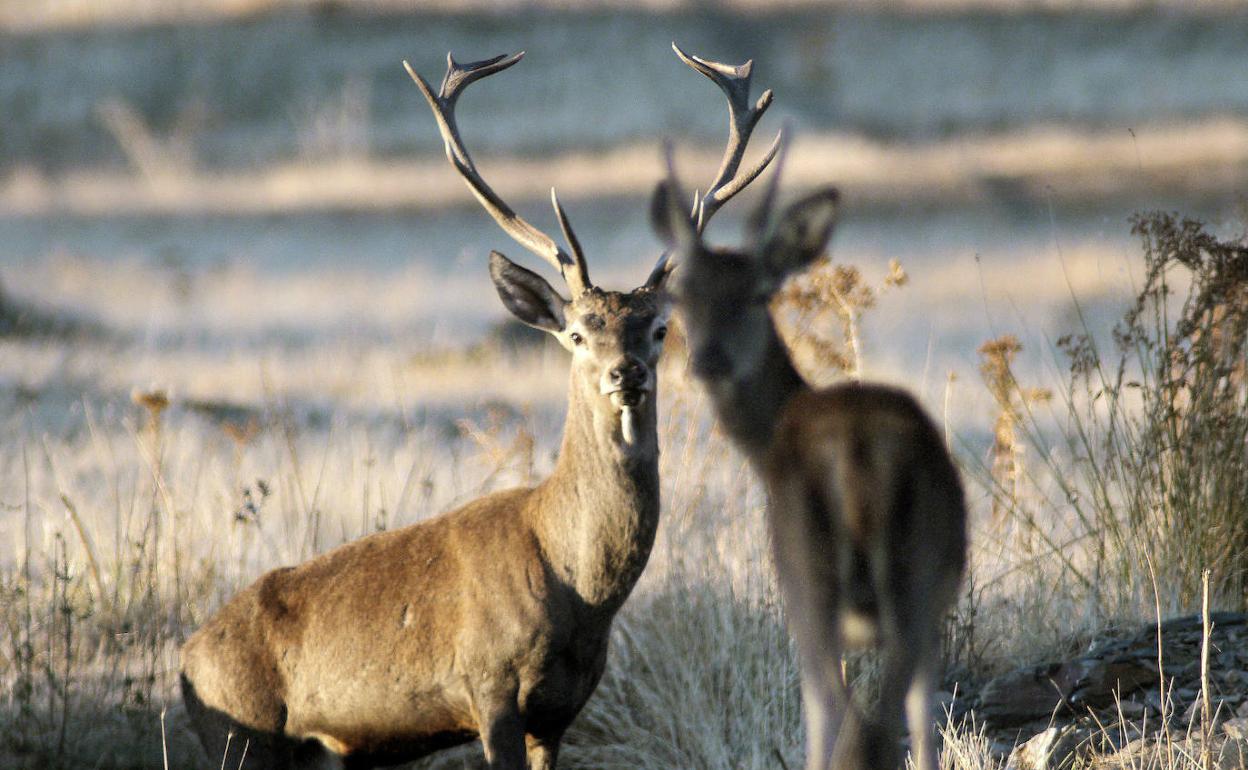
[980,213,1248,614]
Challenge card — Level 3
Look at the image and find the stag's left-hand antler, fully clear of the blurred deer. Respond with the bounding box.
[403,51,593,298]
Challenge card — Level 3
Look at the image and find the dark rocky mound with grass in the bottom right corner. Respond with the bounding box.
[953,613,1248,770]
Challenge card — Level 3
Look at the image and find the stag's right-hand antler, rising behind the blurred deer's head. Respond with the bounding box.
[671,42,784,233]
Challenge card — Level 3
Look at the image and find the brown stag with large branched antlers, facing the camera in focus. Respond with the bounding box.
[181,51,761,770]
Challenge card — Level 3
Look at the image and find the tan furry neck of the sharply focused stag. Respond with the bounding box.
[534,373,659,616]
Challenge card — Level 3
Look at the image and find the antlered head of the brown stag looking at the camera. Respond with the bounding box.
[404,44,781,449]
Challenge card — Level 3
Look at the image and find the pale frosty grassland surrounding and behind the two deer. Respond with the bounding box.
[0,0,1248,770]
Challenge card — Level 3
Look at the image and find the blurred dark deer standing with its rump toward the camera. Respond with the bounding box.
[651,49,967,770]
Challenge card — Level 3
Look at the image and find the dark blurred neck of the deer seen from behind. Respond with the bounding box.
[710,318,810,465]
